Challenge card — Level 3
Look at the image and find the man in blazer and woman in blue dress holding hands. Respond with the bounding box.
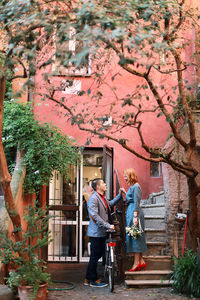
[84,169,147,287]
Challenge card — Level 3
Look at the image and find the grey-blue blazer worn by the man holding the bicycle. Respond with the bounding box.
[87,192,122,237]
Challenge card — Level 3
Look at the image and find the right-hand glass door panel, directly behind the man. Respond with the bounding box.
[79,148,113,261]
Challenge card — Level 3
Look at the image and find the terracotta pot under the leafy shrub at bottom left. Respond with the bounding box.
[18,283,47,300]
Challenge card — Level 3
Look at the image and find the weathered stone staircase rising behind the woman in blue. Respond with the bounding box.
[125,192,172,287]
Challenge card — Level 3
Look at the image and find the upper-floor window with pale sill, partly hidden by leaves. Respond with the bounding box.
[53,27,91,76]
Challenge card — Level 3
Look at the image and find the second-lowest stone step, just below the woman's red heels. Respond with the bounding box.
[125,270,172,280]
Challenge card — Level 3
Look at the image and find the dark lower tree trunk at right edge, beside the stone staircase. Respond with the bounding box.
[187,178,200,251]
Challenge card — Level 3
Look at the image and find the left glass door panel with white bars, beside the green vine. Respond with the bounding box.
[48,166,79,262]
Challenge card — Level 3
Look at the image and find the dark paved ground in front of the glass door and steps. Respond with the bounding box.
[48,264,195,300]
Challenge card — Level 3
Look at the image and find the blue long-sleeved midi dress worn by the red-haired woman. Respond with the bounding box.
[126,183,147,253]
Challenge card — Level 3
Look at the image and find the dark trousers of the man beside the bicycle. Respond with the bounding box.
[86,237,106,281]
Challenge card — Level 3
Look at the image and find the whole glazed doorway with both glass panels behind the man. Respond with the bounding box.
[48,146,113,262]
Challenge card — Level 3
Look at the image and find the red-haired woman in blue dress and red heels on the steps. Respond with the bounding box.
[124,169,147,272]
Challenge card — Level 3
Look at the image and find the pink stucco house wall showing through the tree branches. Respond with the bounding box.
[34,1,198,199]
